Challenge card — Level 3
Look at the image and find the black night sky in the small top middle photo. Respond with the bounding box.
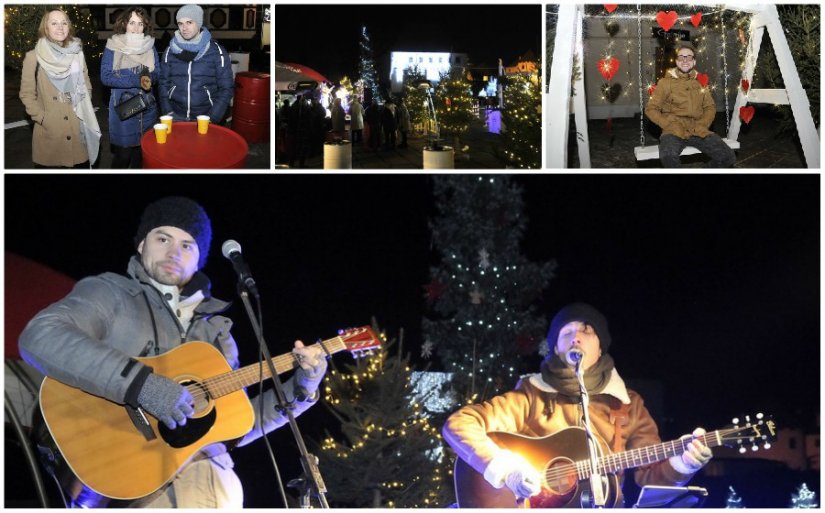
[275,3,542,82]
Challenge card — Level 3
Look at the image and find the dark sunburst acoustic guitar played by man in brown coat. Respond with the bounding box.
[455,413,776,508]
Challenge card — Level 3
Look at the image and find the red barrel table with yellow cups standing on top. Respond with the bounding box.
[140,121,249,169]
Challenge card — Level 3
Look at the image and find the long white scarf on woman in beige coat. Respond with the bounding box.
[34,38,100,166]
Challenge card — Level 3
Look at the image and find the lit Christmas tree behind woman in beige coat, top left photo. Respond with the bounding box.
[4,4,103,69]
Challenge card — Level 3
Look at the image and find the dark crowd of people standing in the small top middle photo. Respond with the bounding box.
[275,93,412,167]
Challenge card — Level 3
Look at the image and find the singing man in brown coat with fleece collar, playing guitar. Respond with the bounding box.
[443,303,712,507]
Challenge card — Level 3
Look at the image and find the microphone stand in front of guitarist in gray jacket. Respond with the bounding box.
[238,281,329,509]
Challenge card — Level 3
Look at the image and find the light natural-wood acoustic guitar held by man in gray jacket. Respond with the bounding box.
[40,326,381,500]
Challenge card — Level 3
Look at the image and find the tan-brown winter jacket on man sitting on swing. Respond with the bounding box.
[645,68,716,139]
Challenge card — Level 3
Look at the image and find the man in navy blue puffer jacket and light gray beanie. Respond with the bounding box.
[159,4,235,123]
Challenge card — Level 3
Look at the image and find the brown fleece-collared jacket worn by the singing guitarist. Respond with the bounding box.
[443,370,691,486]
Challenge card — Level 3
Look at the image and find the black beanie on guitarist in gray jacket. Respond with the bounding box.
[135,196,212,269]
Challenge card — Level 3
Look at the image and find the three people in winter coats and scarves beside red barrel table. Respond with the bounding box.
[20,4,234,168]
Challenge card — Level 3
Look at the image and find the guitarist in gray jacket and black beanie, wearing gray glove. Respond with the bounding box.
[20,197,327,508]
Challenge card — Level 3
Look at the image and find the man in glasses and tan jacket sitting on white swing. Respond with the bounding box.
[645,44,736,168]
